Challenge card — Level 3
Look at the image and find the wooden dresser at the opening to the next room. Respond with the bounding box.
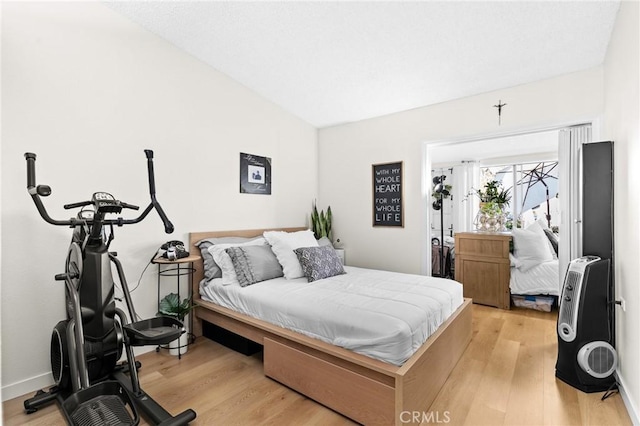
[454,232,511,309]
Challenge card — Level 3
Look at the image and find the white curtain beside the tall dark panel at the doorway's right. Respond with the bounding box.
[558,124,591,288]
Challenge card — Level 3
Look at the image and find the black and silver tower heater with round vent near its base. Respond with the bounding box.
[556,256,618,392]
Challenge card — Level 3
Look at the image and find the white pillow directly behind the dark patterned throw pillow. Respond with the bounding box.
[262,229,318,280]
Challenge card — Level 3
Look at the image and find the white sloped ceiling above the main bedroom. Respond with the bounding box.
[107,0,619,127]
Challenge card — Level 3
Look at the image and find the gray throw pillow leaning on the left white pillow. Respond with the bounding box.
[226,246,283,287]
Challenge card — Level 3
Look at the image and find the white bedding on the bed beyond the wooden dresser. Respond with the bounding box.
[509,259,560,296]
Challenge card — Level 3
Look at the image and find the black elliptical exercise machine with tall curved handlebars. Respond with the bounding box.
[24,150,196,426]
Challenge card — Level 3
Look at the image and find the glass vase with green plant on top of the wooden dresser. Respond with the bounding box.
[471,180,511,232]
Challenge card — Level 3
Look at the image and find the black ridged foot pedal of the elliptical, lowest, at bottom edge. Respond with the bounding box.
[71,395,138,426]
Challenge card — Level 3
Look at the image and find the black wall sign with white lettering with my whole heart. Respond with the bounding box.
[373,161,404,227]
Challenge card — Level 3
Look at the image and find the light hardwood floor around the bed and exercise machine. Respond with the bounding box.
[3,305,631,426]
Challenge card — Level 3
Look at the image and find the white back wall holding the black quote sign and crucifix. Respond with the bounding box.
[318,67,603,273]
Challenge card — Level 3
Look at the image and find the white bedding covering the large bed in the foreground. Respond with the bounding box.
[200,266,463,365]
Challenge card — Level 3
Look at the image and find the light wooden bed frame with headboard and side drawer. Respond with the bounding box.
[189,228,472,425]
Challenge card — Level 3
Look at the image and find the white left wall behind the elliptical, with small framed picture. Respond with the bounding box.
[1,2,317,400]
